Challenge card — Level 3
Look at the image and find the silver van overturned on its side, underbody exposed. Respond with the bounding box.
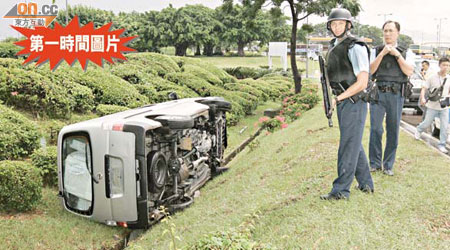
[58,97,231,228]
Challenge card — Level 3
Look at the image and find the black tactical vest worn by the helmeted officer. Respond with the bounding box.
[327,36,370,91]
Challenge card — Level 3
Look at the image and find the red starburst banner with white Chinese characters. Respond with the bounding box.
[12,16,137,70]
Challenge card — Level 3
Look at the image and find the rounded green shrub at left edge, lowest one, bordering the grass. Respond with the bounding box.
[0,161,42,212]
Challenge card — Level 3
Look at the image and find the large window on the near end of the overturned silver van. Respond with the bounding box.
[62,135,92,213]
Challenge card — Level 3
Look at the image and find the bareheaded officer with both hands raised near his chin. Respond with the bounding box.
[369,21,414,176]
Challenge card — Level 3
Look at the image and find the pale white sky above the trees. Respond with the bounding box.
[0,0,450,47]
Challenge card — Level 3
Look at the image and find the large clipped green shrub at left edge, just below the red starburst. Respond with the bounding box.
[0,67,71,117]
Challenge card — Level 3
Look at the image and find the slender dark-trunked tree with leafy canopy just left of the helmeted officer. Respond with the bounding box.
[246,0,361,93]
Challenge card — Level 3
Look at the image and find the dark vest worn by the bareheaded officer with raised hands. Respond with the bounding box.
[373,45,408,83]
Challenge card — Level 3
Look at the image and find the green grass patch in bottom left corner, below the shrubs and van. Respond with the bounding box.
[0,188,127,249]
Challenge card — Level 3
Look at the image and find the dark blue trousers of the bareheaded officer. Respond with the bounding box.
[369,83,404,170]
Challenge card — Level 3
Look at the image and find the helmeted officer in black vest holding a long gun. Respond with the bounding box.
[320,8,374,200]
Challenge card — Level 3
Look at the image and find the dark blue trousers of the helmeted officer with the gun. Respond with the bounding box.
[331,99,374,197]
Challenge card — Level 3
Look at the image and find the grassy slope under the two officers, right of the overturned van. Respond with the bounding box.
[126,105,450,249]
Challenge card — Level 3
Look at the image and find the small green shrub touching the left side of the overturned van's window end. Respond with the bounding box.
[31,146,58,187]
